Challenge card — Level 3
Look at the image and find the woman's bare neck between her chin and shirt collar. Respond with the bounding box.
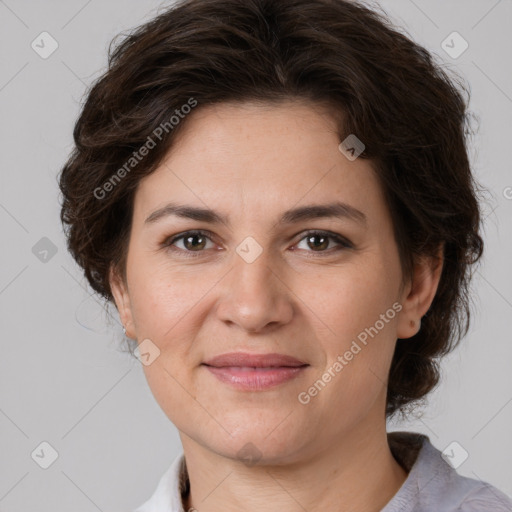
[180,423,407,512]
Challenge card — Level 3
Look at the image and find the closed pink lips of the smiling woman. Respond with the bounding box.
[203,352,309,391]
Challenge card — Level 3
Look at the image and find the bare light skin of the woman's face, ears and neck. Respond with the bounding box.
[110,101,442,512]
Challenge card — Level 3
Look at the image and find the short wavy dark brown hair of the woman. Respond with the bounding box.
[59,0,483,416]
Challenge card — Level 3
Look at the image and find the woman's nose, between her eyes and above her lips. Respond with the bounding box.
[217,246,294,333]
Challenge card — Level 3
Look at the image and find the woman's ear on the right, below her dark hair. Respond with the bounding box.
[397,245,443,339]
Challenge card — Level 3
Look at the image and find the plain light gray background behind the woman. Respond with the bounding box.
[0,0,512,512]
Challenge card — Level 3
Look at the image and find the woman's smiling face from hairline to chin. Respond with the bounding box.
[111,103,435,462]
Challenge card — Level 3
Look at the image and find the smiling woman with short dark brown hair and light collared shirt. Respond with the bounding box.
[60,0,512,512]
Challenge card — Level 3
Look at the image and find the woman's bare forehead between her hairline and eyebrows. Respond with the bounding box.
[135,102,382,225]
